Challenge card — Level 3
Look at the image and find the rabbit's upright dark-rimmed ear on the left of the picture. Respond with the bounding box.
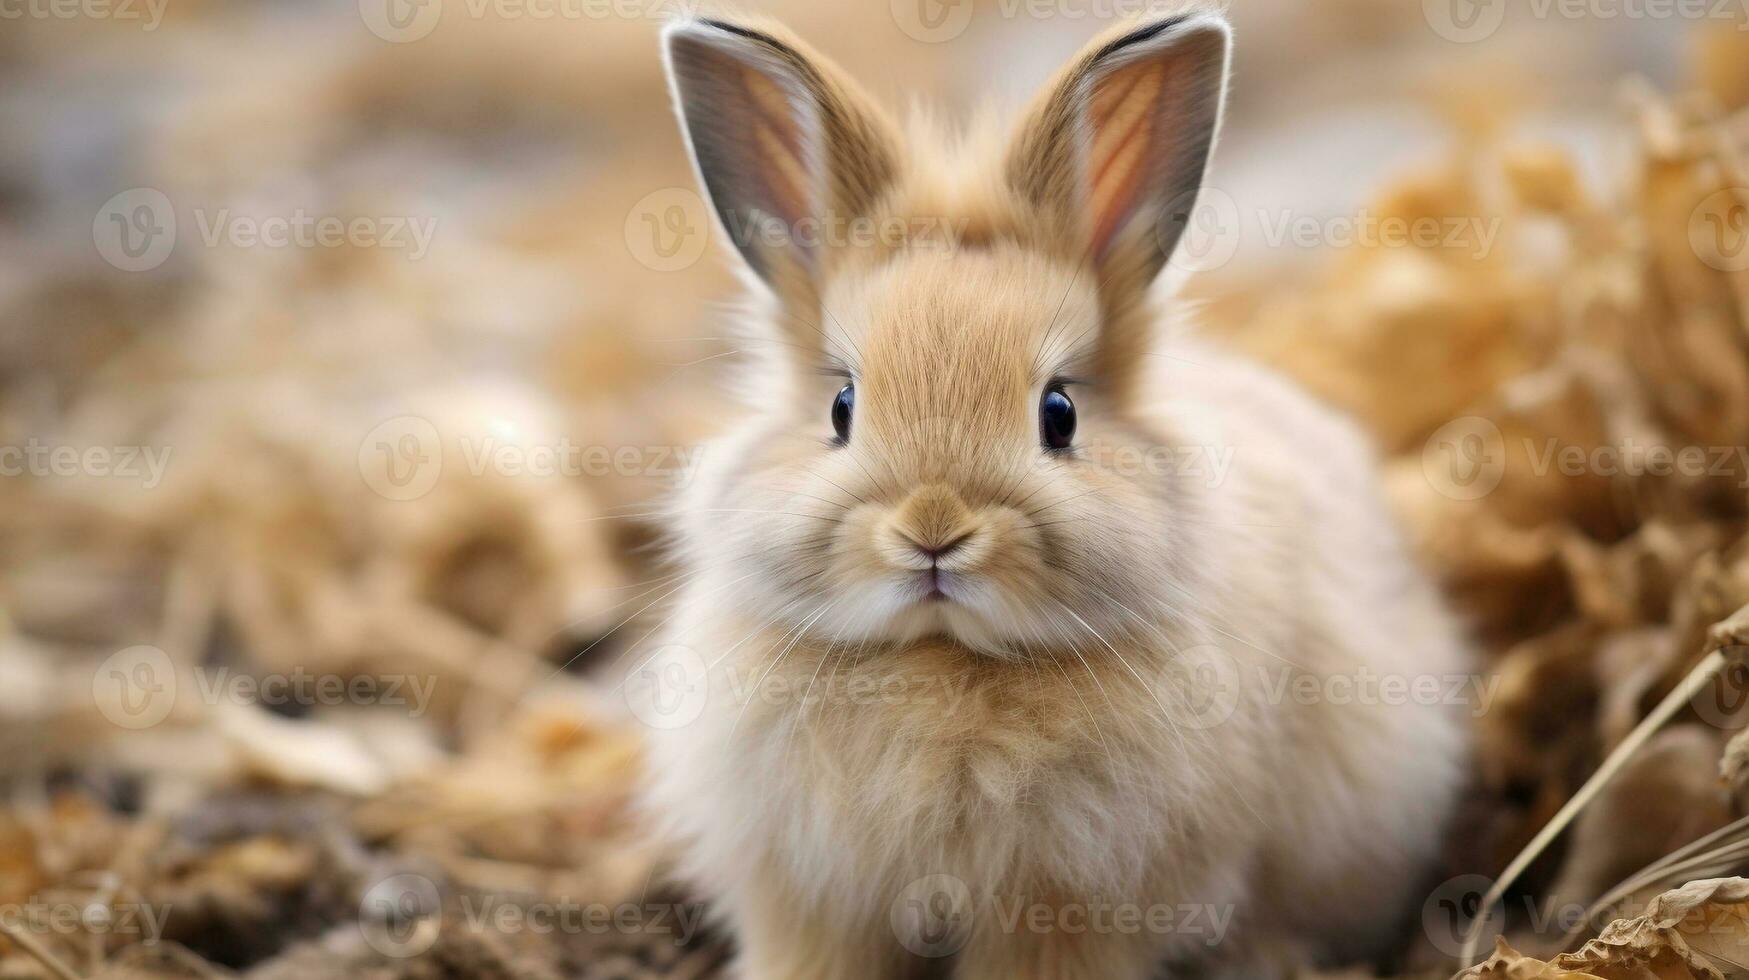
[663,19,899,298]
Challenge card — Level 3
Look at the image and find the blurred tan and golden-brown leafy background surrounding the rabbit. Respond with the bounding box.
[0,0,1749,980]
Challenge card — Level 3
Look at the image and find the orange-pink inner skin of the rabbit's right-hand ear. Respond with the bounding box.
[1088,61,1167,257]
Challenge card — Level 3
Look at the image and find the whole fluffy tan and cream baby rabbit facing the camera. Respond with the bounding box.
[628,9,1466,980]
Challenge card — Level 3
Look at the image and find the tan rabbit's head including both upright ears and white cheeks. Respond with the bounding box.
[666,12,1230,655]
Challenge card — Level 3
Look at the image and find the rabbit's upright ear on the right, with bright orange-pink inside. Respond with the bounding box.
[1007,12,1231,298]
